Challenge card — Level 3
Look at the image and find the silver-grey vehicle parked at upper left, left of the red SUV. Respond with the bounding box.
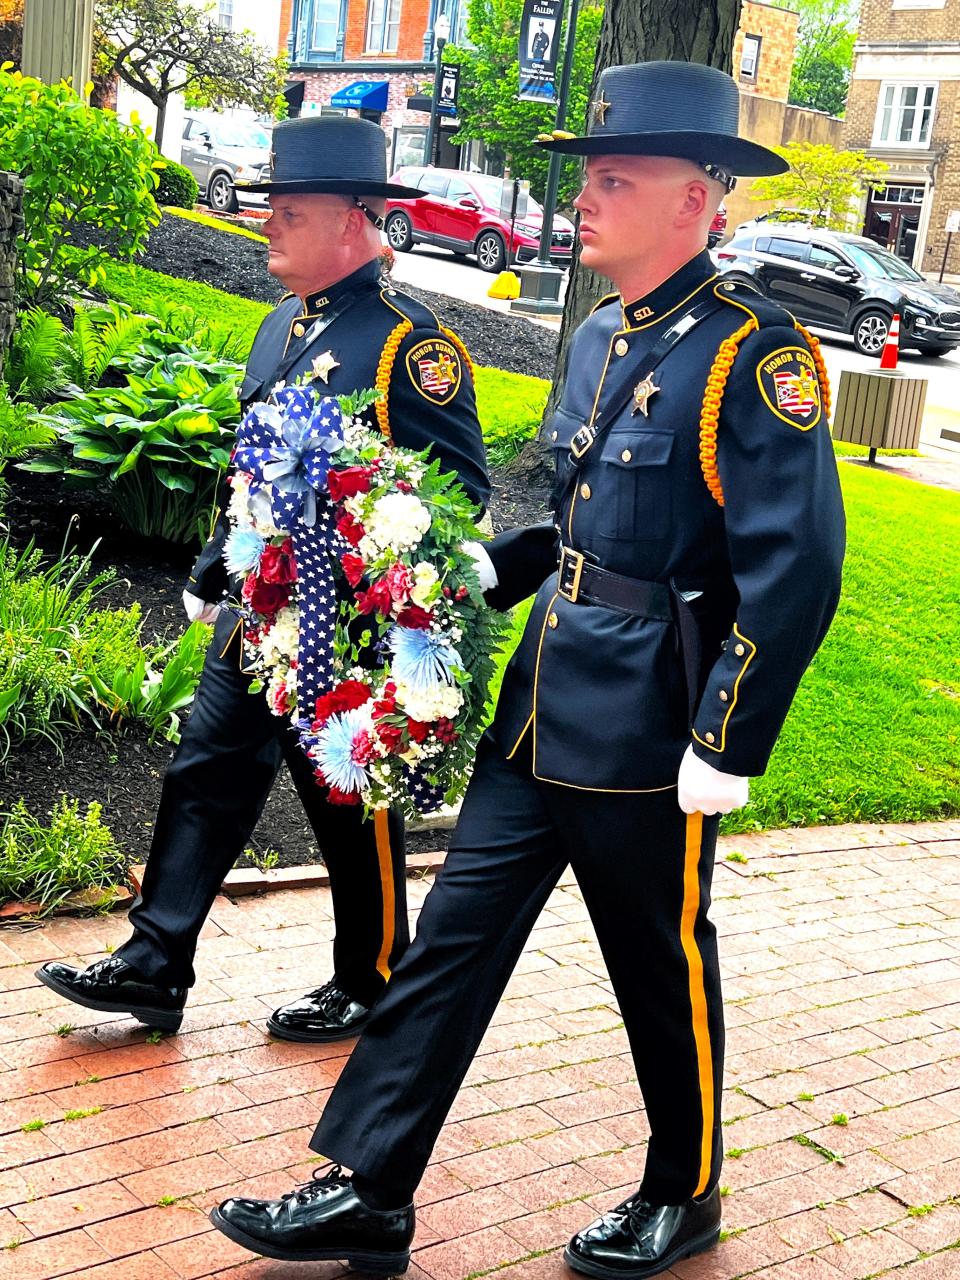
[180,111,270,214]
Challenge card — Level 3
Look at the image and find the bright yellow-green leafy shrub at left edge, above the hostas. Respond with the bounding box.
[0,63,160,302]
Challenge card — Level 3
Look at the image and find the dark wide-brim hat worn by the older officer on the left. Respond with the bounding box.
[234,115,424,200]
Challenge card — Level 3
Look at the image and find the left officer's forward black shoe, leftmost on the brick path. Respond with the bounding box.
[37,956,187,1032]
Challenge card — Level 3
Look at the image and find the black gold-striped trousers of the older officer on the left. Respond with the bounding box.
[116,612,410,1005]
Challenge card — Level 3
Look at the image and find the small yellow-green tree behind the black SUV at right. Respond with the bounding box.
[749,142,890,229]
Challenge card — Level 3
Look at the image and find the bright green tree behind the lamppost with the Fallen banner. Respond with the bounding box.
[443,0,603,204]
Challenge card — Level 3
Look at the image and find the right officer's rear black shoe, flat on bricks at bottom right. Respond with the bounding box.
[563,1187,721,1280]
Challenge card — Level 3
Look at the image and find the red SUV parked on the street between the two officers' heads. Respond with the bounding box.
[384,169,573,271]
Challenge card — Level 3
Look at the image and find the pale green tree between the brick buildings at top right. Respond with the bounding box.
[772,0,859,115]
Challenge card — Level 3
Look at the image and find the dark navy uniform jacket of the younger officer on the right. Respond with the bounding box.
[488,252,844,791]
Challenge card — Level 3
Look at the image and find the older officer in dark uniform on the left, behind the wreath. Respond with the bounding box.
[37,118,489,1041]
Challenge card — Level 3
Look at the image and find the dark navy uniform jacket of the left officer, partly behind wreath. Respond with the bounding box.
[189,261,490,602]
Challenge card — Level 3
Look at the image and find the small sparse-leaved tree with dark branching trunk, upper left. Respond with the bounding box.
[95,0,287,146]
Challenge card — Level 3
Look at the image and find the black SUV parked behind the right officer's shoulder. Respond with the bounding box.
[716,224,960,356]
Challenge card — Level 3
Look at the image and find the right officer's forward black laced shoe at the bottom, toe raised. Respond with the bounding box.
[210,1165,415,1276]
